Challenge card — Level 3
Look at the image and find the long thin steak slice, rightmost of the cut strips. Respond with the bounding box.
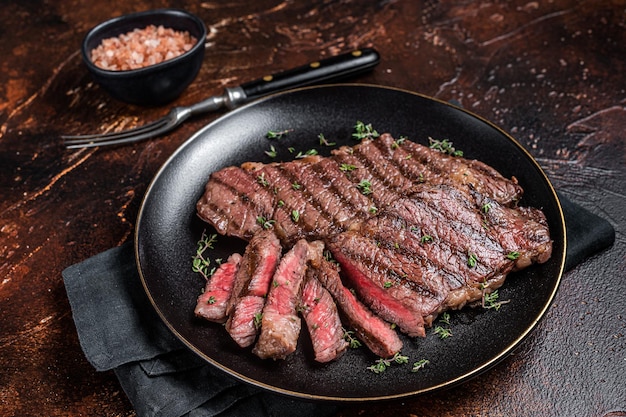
[307,241,402,358]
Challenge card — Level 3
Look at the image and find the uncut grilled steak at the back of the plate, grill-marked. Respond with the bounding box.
[197,134,522,246]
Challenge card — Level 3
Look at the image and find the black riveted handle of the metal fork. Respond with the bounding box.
[240,48,380,99]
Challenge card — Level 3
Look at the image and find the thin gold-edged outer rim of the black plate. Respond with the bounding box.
[133,83,567,403]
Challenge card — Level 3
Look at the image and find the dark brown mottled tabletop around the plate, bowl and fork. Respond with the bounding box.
[0,0,626,417]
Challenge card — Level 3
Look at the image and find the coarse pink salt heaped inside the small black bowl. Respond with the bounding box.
[91,25,198,71]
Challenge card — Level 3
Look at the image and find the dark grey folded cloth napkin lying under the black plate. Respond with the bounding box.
[63,196,615,417]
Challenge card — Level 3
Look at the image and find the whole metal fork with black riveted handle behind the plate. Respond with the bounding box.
[61,48,380,149]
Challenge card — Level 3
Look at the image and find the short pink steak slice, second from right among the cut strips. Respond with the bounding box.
[300,268,348,362]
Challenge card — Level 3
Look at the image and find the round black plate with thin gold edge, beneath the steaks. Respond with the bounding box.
[135,85,565,401]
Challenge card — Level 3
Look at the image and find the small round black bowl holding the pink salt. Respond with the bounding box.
[81,9,207,106]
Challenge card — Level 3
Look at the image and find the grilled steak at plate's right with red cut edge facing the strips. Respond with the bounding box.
[328,185,551,328]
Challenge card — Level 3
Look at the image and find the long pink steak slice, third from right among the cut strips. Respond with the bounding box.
[252,240,309,359]
